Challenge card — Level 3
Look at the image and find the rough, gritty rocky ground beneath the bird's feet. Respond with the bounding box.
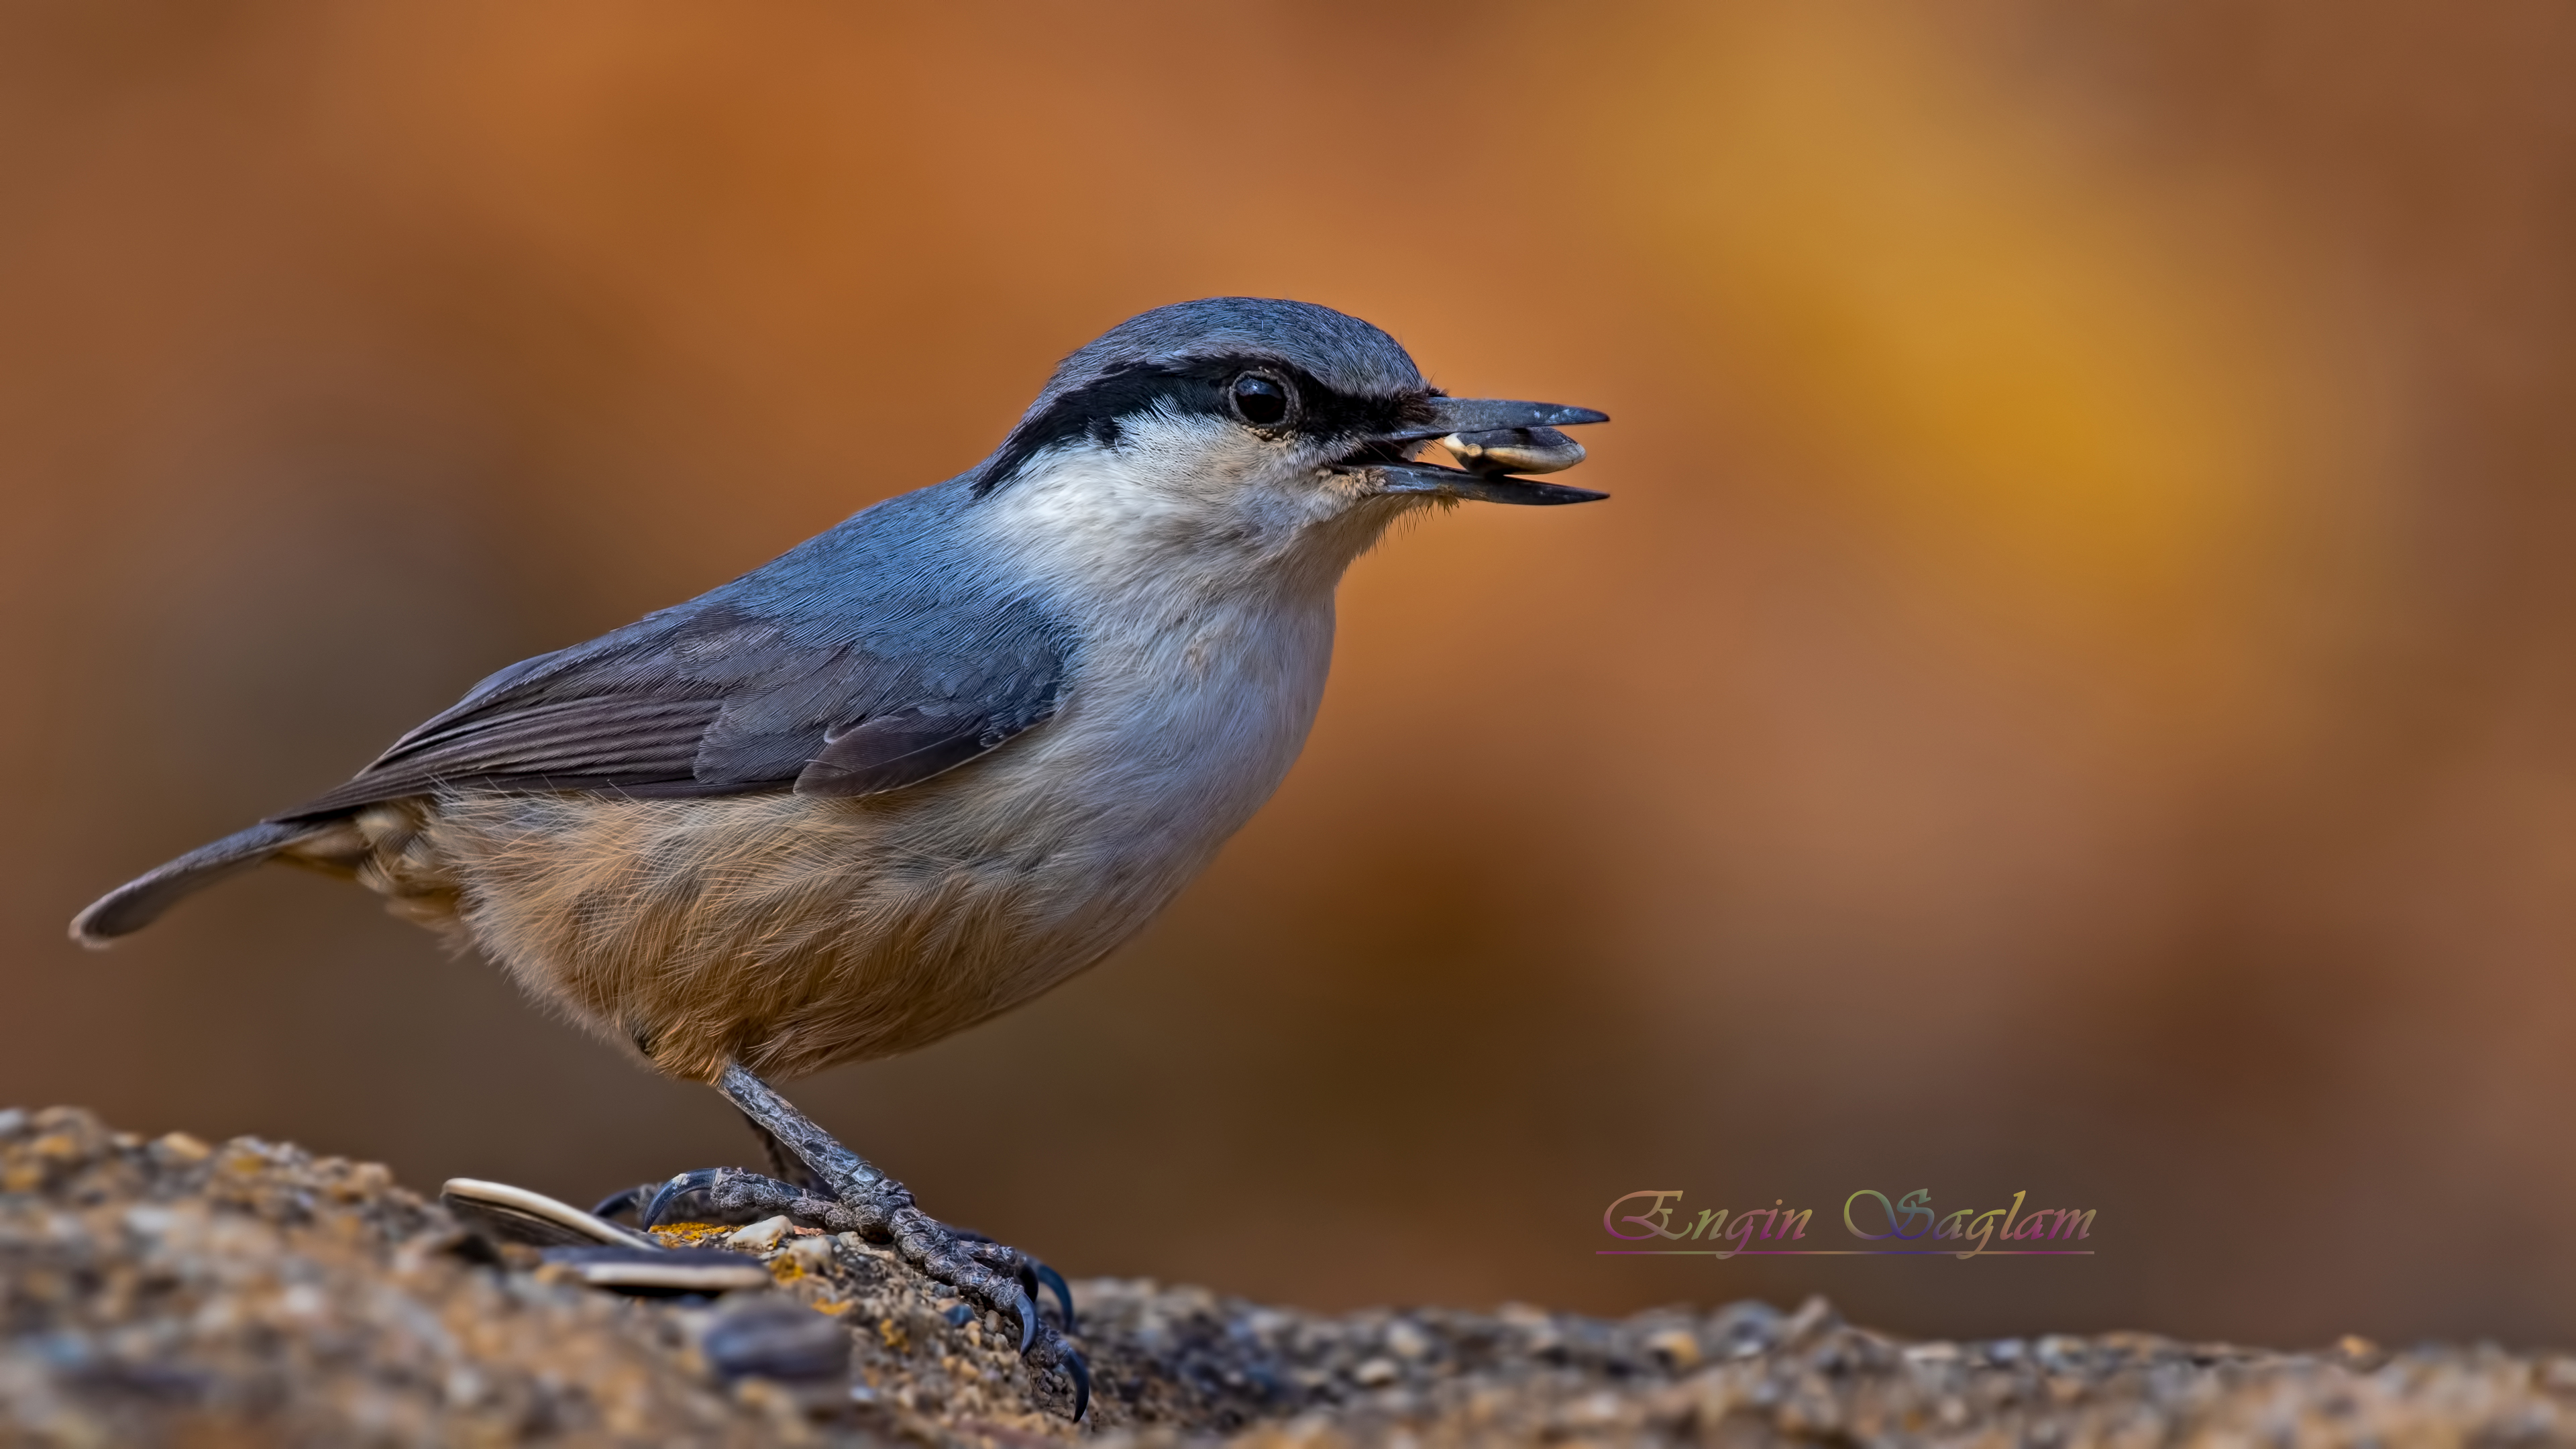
[0,1109,2576,1446]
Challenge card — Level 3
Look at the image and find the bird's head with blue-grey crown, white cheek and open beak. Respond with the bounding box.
[974,297,1607,580]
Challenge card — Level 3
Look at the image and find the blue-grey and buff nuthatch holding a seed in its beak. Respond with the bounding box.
[72,297,1607,1418]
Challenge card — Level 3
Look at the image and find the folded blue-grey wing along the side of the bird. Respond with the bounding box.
[276,575,1069,822]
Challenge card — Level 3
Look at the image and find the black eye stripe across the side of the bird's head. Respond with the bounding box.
[974,356,1432,498]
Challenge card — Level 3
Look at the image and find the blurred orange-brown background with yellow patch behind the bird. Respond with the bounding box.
[0,0,2576,1343]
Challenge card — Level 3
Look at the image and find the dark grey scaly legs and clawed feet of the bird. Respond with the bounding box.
[641,1065,1092,1418]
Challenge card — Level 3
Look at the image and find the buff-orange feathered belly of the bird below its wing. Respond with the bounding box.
[301,778,1198,1080]
